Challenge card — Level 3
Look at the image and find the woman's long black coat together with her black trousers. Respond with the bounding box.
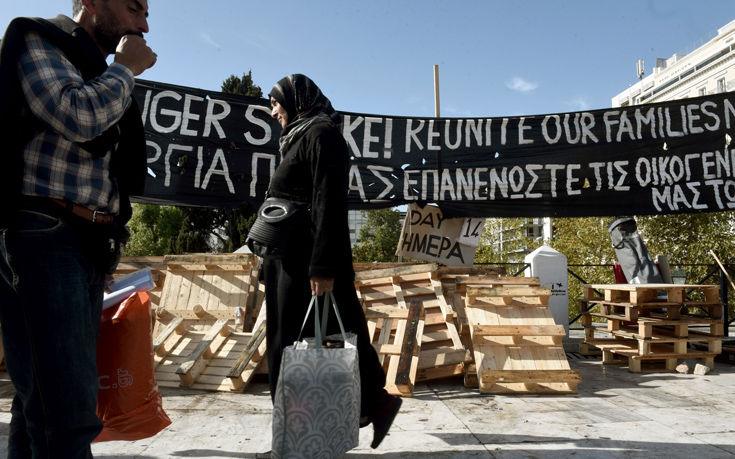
[263,118,385,416]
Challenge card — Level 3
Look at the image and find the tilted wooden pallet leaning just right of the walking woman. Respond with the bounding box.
[355,264,472,395]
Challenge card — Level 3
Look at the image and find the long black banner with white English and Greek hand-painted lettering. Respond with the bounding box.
[135,80,735,217]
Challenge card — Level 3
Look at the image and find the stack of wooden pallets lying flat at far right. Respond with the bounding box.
[580,284,724,373]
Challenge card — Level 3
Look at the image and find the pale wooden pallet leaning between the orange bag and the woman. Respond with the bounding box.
[154,254,266,391]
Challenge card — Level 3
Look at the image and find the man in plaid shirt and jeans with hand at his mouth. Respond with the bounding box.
[0,0,156,458]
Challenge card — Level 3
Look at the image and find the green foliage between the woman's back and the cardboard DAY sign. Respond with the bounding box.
[352,209,402,262]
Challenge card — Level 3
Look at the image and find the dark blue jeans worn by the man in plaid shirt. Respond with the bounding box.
[0,210,106,458]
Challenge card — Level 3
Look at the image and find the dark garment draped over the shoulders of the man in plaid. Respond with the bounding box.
[0,16,146,227]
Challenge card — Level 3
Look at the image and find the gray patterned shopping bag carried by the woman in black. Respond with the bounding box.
[271,293,360,459]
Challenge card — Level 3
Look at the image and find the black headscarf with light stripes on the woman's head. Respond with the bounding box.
[268,73,338,153]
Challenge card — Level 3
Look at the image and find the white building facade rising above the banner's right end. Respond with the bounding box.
[612,20,735,107]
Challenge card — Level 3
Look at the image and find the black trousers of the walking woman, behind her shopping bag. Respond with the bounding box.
[263,259,392,416]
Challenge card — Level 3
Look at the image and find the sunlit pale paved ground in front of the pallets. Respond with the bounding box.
[0,334,735,459]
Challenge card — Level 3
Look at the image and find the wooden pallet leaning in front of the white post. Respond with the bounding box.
[457,277,581,394]
